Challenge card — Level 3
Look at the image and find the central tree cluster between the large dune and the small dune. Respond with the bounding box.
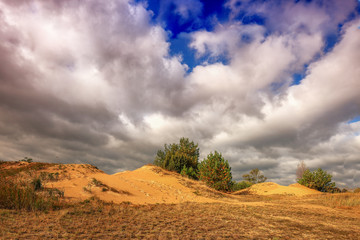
[154,138,267,192]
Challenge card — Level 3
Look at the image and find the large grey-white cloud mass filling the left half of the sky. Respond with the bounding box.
[0,1,186,172]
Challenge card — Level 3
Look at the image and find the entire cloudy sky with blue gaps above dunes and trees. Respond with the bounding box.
[0,0,360,188]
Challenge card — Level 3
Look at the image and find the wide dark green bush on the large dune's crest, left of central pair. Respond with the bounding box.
[154,138,199,178]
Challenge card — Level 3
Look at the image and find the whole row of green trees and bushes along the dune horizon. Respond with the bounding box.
[154,138,345,192]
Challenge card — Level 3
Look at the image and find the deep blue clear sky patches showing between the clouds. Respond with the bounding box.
[136,0,360,72]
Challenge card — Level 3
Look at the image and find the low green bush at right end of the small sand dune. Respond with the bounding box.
[298,168,337,192]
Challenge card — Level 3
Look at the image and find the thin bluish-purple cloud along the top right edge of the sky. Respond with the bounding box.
[225,0,357,34]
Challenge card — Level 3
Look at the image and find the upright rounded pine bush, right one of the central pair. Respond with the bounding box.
[199,151,232,191]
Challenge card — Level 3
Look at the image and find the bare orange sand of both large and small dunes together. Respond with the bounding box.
[39,164,319,204]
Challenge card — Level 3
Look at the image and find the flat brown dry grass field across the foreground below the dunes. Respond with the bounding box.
[0,196,360,239]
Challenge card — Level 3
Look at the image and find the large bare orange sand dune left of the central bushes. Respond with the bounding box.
[48,164,225,204]
